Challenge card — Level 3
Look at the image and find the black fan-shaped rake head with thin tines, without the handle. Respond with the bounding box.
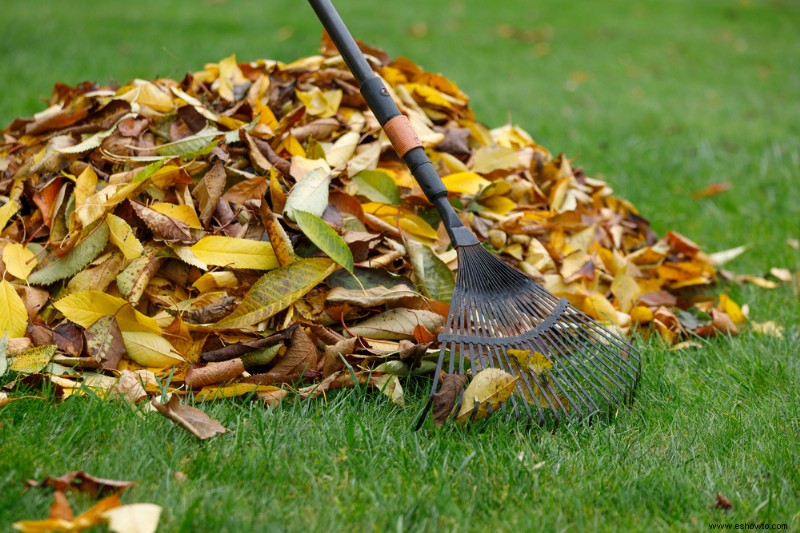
[420,244,640,425]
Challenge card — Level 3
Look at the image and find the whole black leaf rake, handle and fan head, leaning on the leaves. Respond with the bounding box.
[309,0,641,429]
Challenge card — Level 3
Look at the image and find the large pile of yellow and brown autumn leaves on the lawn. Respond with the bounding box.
[0,40,745,426]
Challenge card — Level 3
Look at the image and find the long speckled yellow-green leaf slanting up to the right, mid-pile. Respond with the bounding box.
[213,257,336,329]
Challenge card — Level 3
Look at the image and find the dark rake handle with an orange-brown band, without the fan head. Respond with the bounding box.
[308,0,479,246]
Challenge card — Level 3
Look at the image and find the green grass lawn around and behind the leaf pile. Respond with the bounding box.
[0,0,800,531]
